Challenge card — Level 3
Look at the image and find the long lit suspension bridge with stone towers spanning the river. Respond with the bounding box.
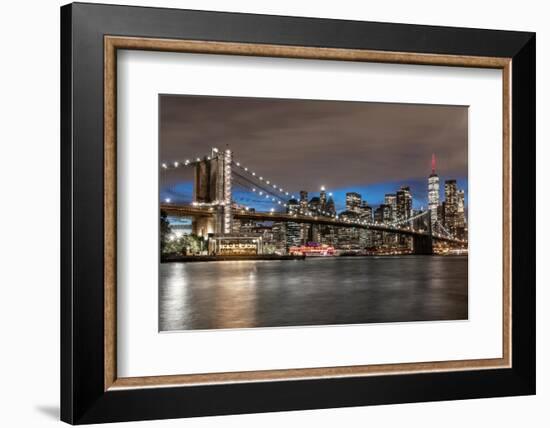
[160,148,467,254]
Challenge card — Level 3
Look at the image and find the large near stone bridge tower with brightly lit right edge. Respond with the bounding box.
[193,148,233,235]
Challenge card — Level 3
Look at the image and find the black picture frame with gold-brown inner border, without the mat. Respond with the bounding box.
[61,4,535,424]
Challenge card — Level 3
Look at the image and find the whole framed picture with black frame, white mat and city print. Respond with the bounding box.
[61,3,535,424]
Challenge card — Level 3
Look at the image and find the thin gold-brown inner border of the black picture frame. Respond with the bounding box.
[104,36,512,391]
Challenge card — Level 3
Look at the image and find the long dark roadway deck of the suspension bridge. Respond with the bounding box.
[160,204,466,244]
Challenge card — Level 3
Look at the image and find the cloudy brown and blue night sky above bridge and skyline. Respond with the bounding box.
[159,95,468,211]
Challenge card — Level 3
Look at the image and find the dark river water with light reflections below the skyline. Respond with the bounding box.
[159,256,468,331]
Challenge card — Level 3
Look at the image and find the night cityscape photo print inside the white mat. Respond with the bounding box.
[159,94,468,332]
